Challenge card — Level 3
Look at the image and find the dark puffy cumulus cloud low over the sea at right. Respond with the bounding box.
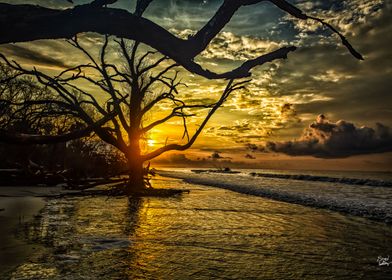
[264,115,392,158]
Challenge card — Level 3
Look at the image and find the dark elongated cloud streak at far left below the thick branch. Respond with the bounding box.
[1,44,69,68]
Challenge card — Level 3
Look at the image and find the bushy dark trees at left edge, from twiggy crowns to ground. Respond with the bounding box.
[0,64,122,177]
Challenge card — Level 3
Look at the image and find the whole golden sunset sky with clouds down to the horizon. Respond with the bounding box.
[0,0,392,171]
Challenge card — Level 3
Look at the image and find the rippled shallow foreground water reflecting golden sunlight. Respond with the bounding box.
[8,178,392,279]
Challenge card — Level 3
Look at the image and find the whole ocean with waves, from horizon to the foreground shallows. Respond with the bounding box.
[159,169,392,223]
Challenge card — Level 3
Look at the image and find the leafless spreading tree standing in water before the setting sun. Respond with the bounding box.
[0,36,247,194]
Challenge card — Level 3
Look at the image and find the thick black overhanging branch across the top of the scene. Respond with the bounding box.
[0,0,362,79]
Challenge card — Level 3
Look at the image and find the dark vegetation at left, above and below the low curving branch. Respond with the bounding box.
[0,65,126,185]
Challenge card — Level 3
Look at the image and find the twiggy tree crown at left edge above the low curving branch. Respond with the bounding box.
[0,64,84,137]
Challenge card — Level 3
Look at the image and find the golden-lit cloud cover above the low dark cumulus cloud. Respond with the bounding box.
[2,0,392,164]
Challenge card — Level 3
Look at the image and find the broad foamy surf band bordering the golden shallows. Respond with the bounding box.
[158,171,392,224]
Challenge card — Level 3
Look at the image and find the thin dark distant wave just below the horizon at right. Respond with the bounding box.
[249,172,392,187]
